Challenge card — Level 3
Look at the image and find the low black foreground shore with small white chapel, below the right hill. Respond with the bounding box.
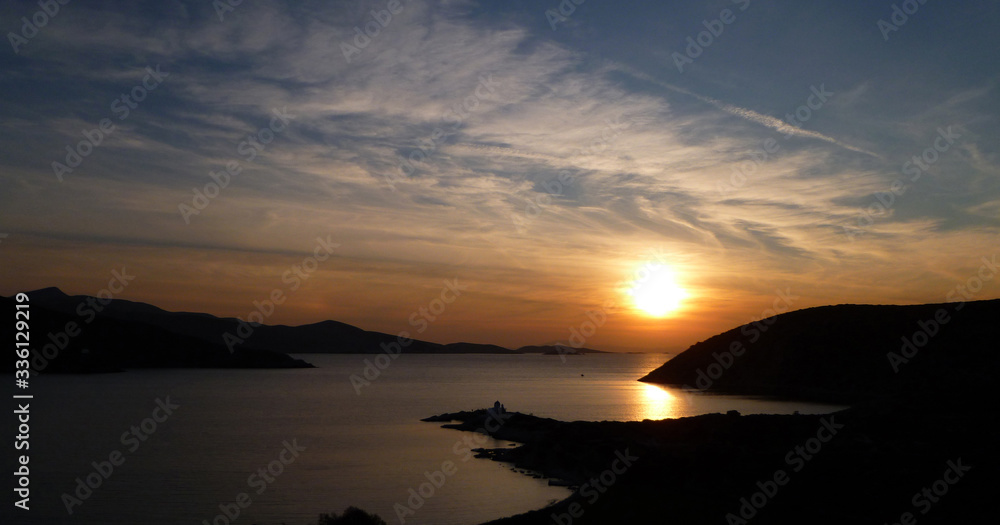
[421,387,1000,525]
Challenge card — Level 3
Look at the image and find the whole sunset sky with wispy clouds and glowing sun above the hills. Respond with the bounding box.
[0,0,1000,351]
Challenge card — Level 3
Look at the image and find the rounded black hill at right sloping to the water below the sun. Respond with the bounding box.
[640,300,1000,403]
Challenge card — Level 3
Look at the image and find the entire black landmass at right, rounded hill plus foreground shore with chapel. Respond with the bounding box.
[425,301,1000,525]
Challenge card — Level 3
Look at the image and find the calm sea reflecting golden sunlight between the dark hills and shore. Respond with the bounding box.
[13,354,844,525]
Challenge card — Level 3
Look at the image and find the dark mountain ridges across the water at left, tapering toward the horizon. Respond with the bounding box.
[0,288,598,372]
